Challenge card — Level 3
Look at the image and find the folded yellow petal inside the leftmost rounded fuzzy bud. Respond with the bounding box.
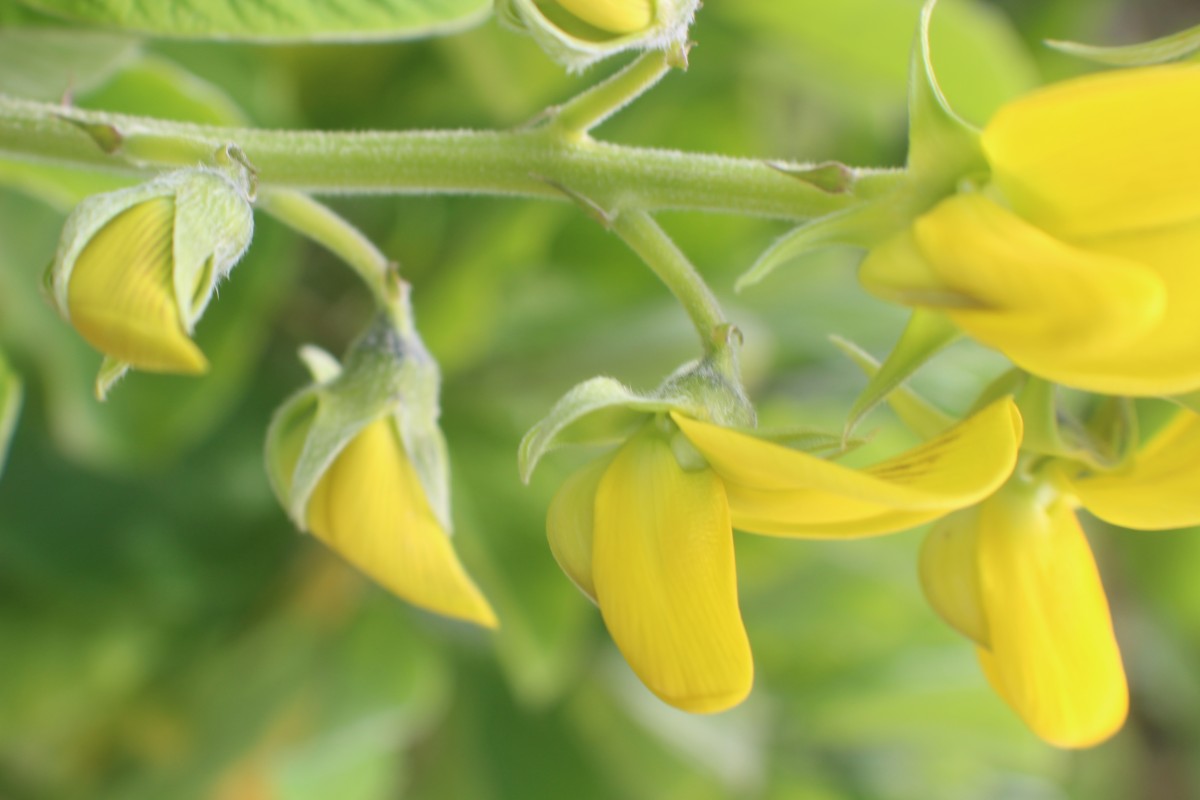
[67,198,208,374]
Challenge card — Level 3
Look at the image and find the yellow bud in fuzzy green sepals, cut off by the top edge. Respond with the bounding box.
[496,0,700,70]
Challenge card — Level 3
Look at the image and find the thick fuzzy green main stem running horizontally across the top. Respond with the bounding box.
[0,97,888,219]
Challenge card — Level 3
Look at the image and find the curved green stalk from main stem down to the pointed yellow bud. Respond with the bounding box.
[256,188,402,315]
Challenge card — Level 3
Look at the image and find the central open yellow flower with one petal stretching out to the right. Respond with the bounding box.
[547,398,1021,712]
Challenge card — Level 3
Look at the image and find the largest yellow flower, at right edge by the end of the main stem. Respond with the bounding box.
[860,65,1200,396]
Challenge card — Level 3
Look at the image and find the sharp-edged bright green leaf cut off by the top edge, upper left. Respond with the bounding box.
[15,0,492,42]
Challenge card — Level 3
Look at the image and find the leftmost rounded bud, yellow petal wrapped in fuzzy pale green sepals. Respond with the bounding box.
[49,168,254,374]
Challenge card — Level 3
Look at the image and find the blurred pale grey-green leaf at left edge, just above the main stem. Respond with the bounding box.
[0,28,138,101]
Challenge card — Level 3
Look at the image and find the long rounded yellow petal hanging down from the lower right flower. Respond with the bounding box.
[978,486,1129,747]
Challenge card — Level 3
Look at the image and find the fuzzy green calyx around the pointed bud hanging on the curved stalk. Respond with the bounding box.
[266,313,452,533]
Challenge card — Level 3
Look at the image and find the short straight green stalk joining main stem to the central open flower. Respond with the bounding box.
[612,210,727,354]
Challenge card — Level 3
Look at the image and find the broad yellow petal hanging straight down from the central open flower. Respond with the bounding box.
[593,428,754,714]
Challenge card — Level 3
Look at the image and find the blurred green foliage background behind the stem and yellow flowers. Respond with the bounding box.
[0,0,1200,800]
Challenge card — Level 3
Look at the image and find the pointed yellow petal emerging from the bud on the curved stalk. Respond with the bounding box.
[308,417,497,627]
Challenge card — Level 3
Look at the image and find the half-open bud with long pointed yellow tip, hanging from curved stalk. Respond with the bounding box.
[266,321,497,627]
